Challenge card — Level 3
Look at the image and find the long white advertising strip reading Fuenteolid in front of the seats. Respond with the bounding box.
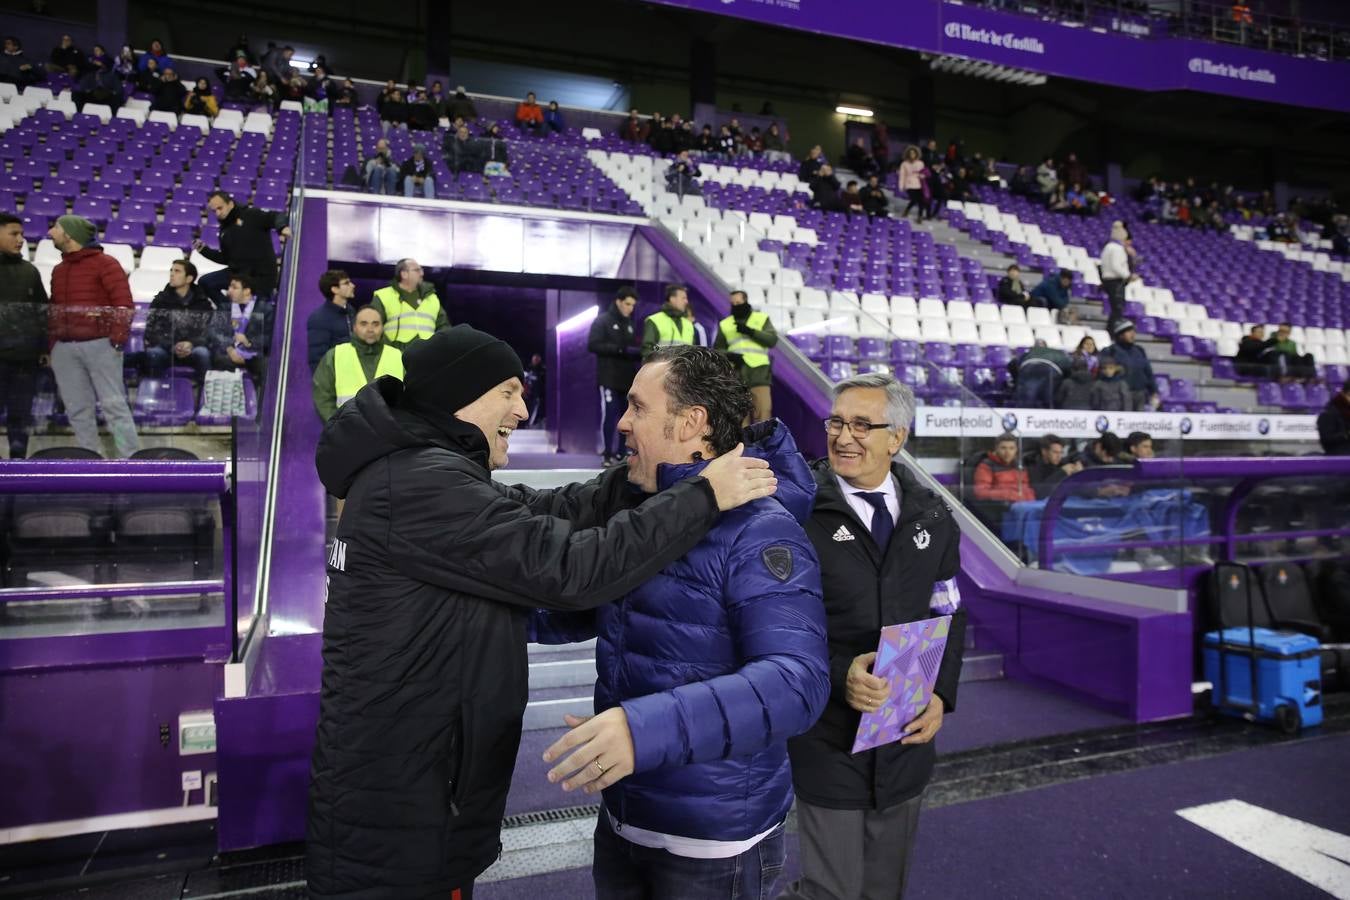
[914,406,1318,441]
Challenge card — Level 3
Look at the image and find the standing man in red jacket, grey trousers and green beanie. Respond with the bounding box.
[47,216,140,456]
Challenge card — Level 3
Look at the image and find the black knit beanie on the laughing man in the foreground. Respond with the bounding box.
[400,325,525,417]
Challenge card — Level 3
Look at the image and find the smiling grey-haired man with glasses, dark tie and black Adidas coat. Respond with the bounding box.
[780,374,967,900]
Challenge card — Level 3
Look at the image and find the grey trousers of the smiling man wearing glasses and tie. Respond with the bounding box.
[779,797,922,900]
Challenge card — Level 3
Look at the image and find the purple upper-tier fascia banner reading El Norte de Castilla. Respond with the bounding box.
[648,0,1350,112]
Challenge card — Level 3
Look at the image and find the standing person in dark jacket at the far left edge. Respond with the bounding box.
[0,212,49,459]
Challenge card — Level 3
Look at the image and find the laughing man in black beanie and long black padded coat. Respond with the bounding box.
[306,325,776,899]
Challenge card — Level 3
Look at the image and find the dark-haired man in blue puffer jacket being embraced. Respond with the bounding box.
[535,347,830,899]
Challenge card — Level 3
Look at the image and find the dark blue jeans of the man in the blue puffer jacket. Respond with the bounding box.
[591,807,787,900]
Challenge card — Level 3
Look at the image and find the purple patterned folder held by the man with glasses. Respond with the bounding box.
[853,615,952,753]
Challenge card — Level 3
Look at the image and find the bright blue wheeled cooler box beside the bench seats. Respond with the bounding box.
[1204,627,1322,731]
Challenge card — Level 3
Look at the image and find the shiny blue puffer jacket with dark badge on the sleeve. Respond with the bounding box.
[536,422,830,841]
